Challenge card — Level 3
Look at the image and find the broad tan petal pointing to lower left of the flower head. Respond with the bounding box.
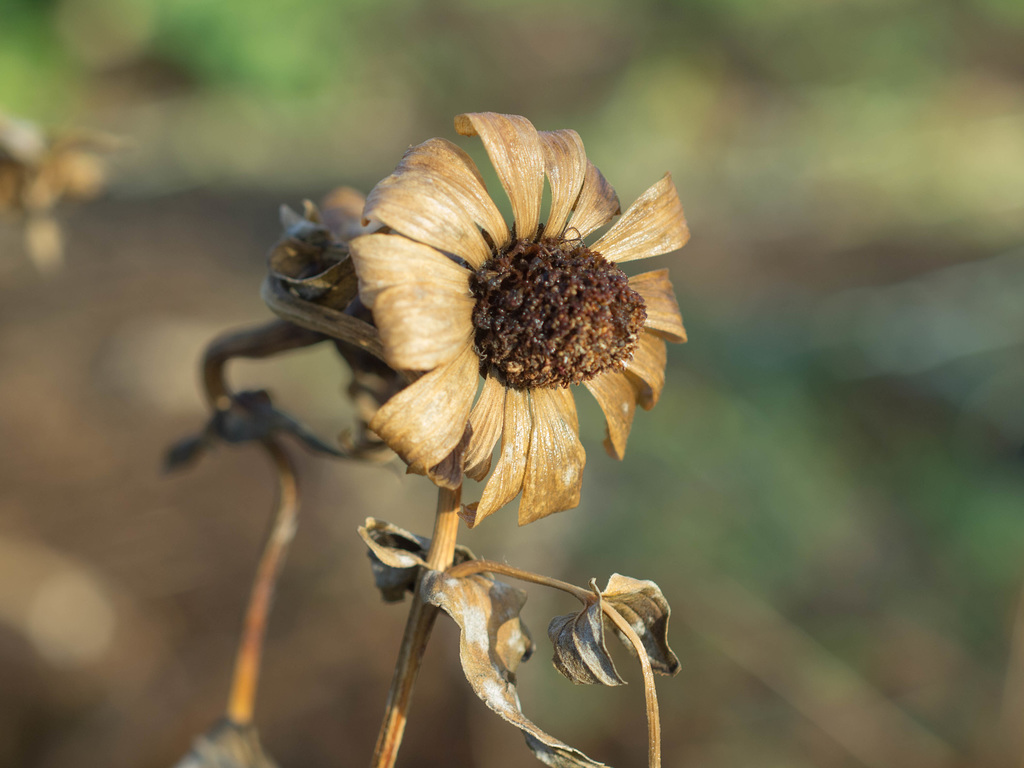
[370,344,479,475]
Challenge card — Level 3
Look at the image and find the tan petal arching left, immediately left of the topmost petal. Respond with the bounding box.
[398,138,510,247]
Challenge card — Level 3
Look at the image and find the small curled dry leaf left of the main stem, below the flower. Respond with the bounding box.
[358,517,476,602]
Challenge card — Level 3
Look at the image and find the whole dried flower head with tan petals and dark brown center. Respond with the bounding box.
[350,113,689,525]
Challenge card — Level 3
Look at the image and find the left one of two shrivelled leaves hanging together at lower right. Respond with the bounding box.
[548,595,626,685]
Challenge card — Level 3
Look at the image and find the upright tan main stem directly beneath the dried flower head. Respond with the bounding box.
[371,486,462,768]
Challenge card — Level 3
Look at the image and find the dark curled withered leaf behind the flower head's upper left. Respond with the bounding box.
[267,201,358,309]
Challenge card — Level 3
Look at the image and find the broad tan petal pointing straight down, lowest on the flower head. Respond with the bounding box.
[519,387,587,525]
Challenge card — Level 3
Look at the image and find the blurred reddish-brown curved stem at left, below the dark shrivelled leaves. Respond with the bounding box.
[227,438,299,725]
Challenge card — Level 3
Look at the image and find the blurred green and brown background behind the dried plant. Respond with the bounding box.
[0,0,1024,768]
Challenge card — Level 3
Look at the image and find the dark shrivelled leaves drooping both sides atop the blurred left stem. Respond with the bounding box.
[164,390,345,471]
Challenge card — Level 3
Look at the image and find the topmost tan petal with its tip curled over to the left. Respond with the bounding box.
[455,112,544,238]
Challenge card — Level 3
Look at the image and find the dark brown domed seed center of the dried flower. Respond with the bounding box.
[469,238,647,389]
